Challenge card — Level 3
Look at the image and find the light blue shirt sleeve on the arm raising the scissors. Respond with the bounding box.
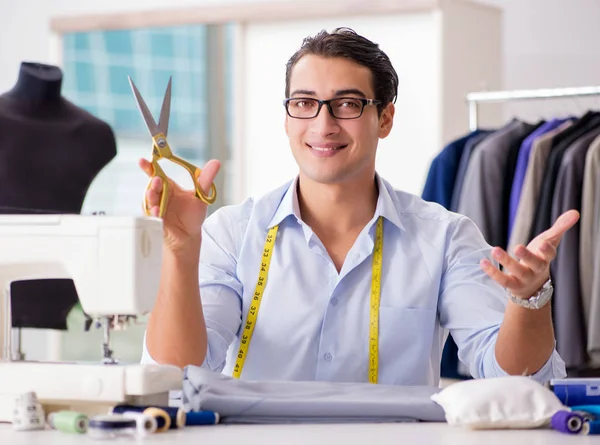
[141,203,247,372]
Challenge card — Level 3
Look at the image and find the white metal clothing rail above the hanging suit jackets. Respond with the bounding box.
[467,86,600,131]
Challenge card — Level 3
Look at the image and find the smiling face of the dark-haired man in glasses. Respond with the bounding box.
[285,55,394,184]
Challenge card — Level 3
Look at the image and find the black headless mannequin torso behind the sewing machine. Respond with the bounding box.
[0,62,116,329]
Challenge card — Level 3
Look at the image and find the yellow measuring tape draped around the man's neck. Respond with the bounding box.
[233,217,383,383]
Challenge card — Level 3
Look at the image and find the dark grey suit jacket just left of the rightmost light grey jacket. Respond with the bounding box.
[550,128,600,368]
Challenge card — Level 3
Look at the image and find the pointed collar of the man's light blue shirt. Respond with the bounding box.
[267,173,404,230]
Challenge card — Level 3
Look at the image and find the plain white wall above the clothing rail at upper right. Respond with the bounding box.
[478,0,600,119]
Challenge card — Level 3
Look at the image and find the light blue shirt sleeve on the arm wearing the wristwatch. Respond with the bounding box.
[438,216,566,383]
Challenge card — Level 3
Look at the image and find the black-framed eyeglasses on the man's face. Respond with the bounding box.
[283,97,381,119]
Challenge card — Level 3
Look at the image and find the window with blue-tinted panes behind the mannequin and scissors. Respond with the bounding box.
[60,25,233,362]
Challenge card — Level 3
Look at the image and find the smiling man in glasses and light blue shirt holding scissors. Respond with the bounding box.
[140,29,578,385]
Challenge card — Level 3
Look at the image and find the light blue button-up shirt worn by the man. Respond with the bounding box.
[142,176,566,385]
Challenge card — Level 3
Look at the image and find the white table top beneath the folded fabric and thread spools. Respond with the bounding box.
[0,423,598,445]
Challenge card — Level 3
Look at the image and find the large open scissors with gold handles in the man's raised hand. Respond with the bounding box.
[128,77,217,218]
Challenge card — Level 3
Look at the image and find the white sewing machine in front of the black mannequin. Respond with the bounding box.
[0,215,183,422]
